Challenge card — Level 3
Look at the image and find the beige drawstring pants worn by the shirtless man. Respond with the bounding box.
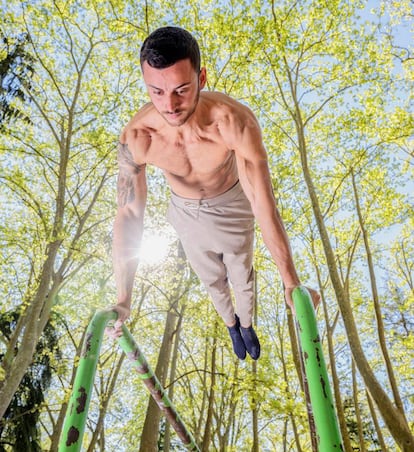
[167,182,254,326]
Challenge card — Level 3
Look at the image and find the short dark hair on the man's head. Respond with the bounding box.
[140,27,200,73]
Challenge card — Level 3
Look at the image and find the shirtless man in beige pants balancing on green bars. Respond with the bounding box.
[112,27,319,359]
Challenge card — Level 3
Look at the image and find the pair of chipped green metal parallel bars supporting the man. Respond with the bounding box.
[59,287,343,452]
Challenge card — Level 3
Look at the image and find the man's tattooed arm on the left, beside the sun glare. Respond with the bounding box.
[111,143,147,336]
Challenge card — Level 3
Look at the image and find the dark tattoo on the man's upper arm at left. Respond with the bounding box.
[117,143,142,207]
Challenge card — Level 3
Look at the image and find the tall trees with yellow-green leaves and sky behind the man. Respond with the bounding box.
[0,0,414,451]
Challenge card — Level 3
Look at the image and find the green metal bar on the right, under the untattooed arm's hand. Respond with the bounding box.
[292,286,344,452]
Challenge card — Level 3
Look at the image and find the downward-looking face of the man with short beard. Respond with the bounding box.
[142,59,206,127]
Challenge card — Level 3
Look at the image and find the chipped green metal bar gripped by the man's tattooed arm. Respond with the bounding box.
[58,310,200,452]
